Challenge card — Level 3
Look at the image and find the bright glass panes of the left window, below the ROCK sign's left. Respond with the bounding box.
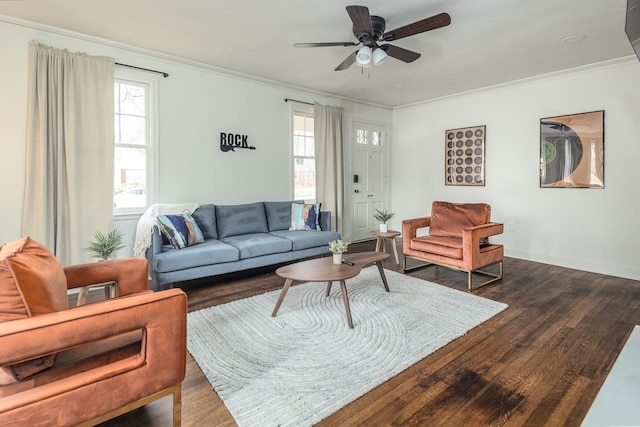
[113,79,152,214]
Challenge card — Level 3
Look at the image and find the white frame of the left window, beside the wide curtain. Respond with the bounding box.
[112,69,159,218]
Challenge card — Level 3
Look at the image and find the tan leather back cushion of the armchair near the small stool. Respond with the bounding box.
[429,202,491,238]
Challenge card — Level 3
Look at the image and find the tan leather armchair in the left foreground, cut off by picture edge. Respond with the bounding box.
[0,238,187,426]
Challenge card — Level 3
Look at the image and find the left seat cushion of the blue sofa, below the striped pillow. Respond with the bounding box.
[153,239,240,273]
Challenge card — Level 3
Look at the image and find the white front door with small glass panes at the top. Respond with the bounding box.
[350,122,389,241]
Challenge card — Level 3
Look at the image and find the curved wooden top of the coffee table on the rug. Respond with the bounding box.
[276,252,389,282]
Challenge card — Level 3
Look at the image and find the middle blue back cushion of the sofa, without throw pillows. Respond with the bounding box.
[216,202,268,239]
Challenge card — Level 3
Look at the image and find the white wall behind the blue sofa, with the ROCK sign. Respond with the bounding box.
[0,21,392,256]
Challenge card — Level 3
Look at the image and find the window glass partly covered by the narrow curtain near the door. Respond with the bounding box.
[293,111,316,202]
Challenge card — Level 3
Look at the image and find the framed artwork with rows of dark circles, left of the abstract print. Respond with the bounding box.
[444,126,487,186]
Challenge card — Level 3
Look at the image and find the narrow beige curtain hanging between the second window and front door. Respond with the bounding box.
[313,102,344,233]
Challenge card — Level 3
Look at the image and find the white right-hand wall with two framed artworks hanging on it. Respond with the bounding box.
[391,58,640,280]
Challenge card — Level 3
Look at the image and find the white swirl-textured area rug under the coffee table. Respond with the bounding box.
[187,267,507,427]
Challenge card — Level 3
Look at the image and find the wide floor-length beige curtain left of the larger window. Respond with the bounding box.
[22,41,114,265]
